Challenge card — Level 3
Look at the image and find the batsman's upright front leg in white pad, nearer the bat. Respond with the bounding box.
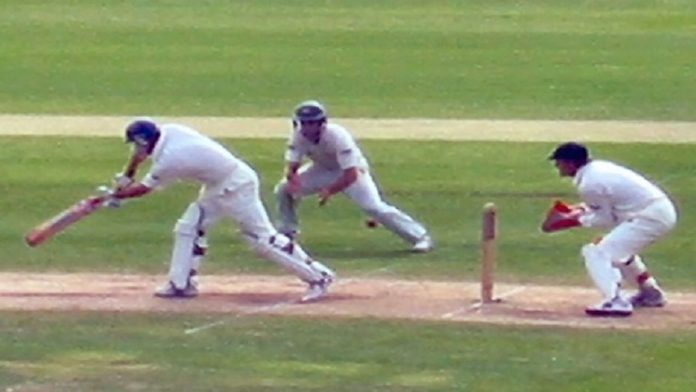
[155,202,205,298]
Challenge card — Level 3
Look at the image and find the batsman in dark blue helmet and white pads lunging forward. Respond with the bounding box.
[112,120,335,302]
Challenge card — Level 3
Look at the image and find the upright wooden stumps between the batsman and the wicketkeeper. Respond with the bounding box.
[481,202,499,304]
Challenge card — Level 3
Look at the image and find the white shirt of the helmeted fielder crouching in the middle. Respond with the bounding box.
[285,123,368,170]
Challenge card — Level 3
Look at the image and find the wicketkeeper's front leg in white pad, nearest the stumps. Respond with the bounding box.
[582,244,633,316]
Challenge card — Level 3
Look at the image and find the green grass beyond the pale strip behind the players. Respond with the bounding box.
[0,0,696,120]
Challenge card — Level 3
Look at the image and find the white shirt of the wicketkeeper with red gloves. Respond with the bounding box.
[573,160,669,226]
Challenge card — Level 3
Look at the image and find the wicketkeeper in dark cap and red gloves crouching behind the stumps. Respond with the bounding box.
[542,142,677,316]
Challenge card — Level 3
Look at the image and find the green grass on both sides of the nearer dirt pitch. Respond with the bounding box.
[0,137,696,391]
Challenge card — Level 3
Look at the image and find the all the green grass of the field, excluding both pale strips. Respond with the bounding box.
[0,0,696,391]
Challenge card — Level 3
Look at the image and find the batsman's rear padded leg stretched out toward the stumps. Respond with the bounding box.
[222,174,335,301]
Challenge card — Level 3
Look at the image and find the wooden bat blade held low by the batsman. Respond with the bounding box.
[24,196,104,247]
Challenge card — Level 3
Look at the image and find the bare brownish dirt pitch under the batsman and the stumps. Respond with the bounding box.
[0,273,696,333]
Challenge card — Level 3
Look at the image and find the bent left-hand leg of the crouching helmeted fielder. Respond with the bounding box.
[274,163,339,238]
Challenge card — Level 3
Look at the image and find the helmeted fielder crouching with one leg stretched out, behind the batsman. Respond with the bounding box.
[275,101,433,252]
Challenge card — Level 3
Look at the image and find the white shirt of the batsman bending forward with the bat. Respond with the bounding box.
[142,124,252,193]
